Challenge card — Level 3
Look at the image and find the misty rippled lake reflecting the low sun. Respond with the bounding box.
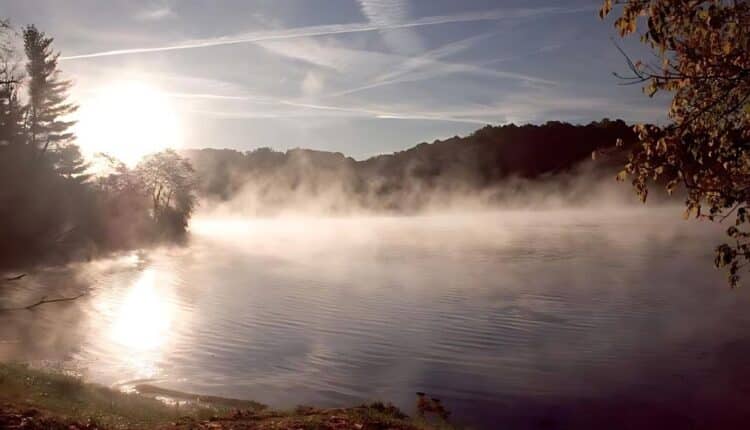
[0,208,750,428]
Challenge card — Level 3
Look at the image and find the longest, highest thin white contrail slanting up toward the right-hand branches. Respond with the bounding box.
[60,7,593,60]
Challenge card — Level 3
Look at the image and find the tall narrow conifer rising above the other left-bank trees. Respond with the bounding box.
[23,25,78,154]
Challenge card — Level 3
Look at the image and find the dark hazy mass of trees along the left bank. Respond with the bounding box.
[0,21,196,266]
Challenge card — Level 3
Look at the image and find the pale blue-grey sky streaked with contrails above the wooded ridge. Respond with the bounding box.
[0,0,665,159]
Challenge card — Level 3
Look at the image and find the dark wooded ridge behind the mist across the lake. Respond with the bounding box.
[183,119,635,212]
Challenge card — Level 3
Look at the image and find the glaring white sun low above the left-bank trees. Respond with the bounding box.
[76,81,182,166]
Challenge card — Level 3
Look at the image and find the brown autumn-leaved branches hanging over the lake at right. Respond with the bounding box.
[600,0,750,286]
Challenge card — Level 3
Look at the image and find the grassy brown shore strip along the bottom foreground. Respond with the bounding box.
[0,363,453,430]
